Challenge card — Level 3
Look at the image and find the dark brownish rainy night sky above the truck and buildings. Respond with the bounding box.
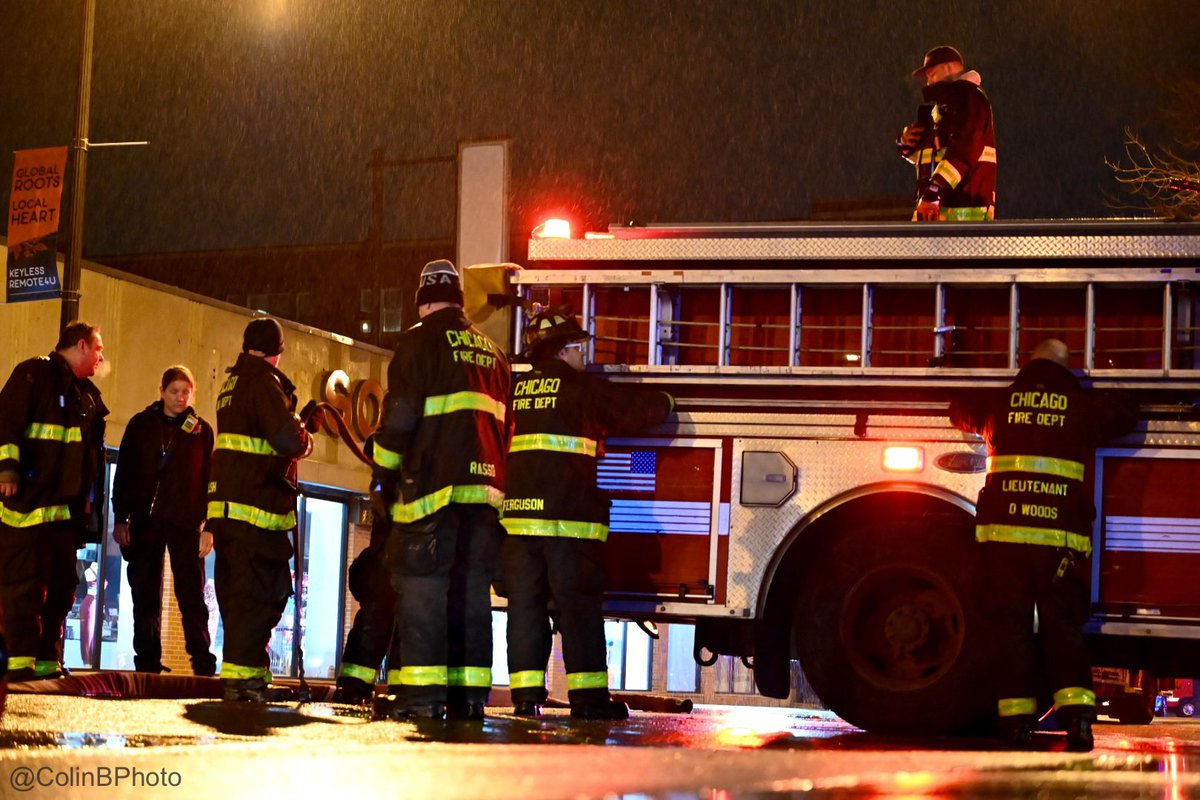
[0,0,1200,258]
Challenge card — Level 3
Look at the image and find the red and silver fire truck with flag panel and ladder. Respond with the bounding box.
[467,219,1200,734]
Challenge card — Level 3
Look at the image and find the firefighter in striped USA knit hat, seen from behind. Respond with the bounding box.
[374,260,511,720]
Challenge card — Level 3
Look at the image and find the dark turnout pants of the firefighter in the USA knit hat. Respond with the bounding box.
[388,504,503,708]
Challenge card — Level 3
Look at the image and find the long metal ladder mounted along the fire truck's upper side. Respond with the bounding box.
[512,267,1200,378]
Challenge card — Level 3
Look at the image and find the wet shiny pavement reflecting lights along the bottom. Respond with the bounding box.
[0,694,1200,800]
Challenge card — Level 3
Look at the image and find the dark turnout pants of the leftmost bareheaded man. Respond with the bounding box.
[0,524,79,674]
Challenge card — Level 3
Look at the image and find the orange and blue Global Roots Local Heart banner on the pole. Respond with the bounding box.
[5,148,67,302]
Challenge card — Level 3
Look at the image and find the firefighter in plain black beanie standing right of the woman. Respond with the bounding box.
[208,318,312,702]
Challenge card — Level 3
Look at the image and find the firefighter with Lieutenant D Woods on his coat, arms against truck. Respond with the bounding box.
[950,339,1138,751]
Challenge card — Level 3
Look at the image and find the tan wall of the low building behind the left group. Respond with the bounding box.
[0,245,391,493]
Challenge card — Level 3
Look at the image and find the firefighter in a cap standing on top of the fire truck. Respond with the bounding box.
[896,46,996,222]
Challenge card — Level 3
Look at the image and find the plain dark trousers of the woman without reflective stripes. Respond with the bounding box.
[122,518,217,675]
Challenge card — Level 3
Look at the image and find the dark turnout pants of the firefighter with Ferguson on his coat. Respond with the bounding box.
[504,536,608,705]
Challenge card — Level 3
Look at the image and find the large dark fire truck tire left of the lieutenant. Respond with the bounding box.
[792,518,995,735]
